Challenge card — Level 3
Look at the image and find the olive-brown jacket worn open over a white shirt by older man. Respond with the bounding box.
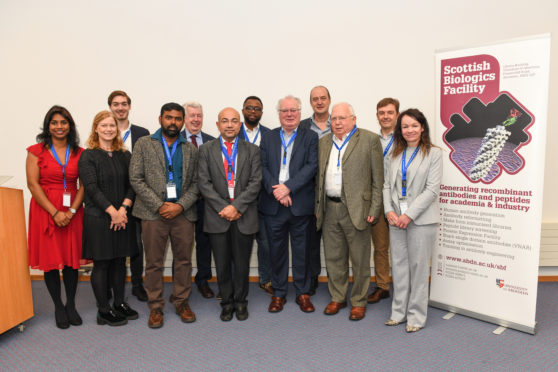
[316,128,384,230]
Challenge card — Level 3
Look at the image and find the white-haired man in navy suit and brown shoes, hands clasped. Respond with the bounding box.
[259,96,318,313]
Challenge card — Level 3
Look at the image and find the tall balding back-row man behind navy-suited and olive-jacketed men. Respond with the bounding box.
[300,85,331,296]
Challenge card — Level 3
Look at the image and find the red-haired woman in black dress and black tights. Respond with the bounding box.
[78,111,138,326]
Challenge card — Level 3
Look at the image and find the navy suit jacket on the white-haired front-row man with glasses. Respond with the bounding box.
[259,127,318,216]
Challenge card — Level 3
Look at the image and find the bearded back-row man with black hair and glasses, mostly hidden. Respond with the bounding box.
[239,96,273,295]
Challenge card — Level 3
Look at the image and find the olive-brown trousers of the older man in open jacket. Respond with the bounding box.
[322,200,371,306]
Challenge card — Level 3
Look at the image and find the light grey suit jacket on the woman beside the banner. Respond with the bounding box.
[384,147,442,225]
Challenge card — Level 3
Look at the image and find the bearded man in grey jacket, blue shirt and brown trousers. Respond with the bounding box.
[130,102,198,328]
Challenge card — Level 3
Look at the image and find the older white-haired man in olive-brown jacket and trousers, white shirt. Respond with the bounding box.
[316,103,384,320]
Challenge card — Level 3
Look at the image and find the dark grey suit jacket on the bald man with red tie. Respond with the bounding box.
[199,139,262,235]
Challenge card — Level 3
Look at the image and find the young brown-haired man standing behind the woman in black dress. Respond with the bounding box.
[108,90,149,302]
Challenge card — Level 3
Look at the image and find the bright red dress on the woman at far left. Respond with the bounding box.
[27,143,87,271]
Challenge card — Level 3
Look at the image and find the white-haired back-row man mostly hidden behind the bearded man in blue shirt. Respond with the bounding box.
[182,102,215,298]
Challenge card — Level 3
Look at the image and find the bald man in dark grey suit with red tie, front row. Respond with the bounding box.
[199,107,262,321]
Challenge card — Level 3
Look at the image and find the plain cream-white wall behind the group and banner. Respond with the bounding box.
[0,0,558,222]
